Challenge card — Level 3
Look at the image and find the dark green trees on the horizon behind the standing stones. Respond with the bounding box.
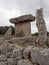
[0,26,49,36]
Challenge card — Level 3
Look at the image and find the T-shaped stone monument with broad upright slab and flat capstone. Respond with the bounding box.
[10,14,35,37]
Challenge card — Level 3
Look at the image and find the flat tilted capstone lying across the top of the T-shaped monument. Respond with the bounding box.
[10,14,35,23]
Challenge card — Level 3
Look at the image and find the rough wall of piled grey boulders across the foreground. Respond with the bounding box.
[0,43,49,65]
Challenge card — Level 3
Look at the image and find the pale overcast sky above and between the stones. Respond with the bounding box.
[0,0,49,33]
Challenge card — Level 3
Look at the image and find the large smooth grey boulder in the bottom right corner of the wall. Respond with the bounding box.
[31,49,49,65]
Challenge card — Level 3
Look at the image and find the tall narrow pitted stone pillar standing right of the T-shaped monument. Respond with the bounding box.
[36,8,47,46]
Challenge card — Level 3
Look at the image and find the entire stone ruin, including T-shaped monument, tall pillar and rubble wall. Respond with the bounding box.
[0,8,49,65]
